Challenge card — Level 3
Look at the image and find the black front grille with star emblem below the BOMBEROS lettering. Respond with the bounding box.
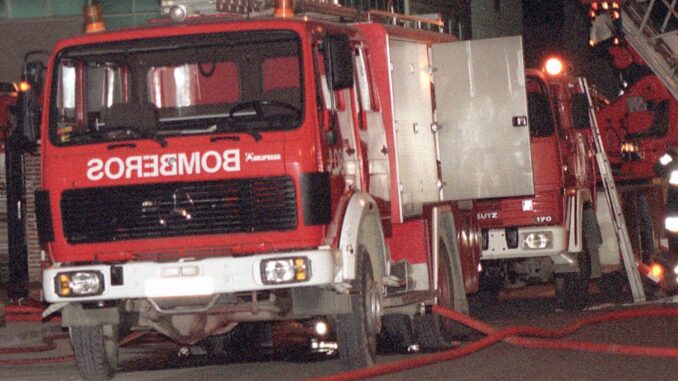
[61,176,297,243]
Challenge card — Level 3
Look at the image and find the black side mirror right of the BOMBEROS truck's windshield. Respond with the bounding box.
[323,35,353,90]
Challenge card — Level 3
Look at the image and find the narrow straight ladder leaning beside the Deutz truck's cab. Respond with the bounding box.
[578,78,645,303]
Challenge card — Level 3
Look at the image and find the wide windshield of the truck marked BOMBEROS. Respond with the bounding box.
[49,30,303,145]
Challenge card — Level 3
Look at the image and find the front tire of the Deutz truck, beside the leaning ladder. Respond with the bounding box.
[556,247,591,311]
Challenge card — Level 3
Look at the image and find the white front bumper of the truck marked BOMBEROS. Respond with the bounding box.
[42,248,341,303]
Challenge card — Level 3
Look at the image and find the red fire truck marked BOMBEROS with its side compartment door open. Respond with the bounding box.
[31,1,531,379]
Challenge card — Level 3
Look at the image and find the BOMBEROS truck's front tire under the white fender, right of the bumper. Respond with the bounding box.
[336,246,381,369]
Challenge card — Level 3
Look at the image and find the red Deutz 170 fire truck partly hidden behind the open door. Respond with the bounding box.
[476,57,600,308]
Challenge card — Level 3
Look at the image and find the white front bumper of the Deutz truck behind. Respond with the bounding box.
[480,226,567,260]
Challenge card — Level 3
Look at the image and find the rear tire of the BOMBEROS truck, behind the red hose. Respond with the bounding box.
[414,243,470,350]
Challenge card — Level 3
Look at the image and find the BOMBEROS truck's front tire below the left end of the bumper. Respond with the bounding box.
[69,325,119,381]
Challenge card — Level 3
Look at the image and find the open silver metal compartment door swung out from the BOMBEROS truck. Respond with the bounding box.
[432,36,534,200]
